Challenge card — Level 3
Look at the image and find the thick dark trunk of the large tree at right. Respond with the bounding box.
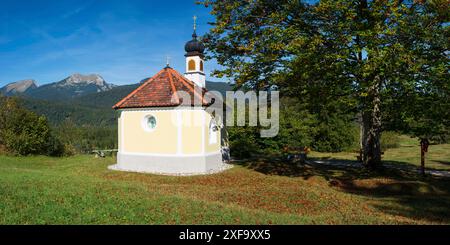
[361,77,381,169]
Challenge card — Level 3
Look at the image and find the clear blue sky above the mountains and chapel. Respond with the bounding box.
[0,0,218,87]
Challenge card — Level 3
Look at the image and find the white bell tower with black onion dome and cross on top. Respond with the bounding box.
[184,16,206,88]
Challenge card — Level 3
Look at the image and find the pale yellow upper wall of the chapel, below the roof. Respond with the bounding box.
[119,109,221,155]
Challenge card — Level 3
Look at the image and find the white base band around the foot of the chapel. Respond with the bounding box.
[108,152,232,175]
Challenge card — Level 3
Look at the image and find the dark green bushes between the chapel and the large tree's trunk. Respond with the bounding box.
[228,98,359,158]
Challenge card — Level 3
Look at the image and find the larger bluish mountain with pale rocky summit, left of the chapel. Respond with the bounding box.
[24,74,115,101]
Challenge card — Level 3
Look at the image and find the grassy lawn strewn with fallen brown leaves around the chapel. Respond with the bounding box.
[0,145,450,224]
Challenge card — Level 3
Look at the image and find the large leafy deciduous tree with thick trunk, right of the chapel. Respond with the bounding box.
[203,0,450,168]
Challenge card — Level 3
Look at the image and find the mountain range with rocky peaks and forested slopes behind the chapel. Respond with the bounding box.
[0,74,232,126]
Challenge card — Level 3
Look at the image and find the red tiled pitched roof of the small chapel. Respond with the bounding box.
[113,67,210,109]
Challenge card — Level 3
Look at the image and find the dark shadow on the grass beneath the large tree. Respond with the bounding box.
[237,158,450,223]
